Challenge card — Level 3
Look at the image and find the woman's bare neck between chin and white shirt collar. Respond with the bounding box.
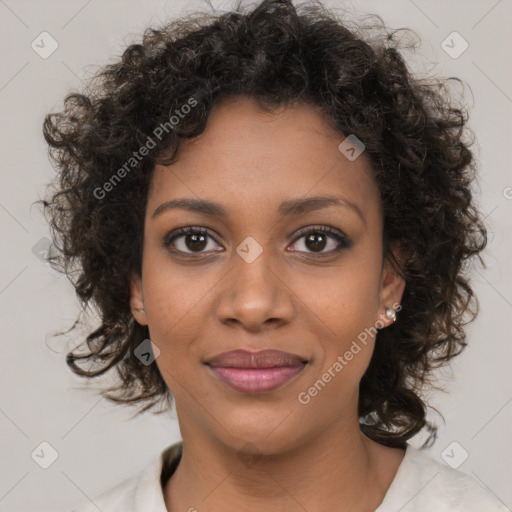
[164,423,405,512]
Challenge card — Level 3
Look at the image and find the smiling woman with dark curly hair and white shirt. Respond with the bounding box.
[44,0,506,512]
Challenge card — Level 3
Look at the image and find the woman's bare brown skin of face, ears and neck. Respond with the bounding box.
[131,97,405,512]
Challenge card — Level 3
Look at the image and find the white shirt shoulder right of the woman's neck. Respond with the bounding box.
[376,445,509,512]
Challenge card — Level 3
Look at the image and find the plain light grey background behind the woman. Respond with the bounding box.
[0,0,512,511]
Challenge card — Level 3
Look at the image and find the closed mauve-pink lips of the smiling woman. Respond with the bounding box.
[205,350,308,395]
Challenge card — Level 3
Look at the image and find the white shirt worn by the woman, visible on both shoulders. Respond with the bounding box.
[71,442,510,512]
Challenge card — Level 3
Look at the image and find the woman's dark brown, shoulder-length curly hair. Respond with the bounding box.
[40,0,487,447]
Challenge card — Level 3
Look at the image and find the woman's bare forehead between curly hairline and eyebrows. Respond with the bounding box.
[148,97,380,223]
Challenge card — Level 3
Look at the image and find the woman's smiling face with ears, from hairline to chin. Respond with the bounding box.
[131,97,404,453]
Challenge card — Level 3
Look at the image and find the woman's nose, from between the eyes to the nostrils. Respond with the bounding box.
[216,250,296,332]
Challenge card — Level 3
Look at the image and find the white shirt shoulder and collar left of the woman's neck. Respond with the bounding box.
[70,443,182,512]
